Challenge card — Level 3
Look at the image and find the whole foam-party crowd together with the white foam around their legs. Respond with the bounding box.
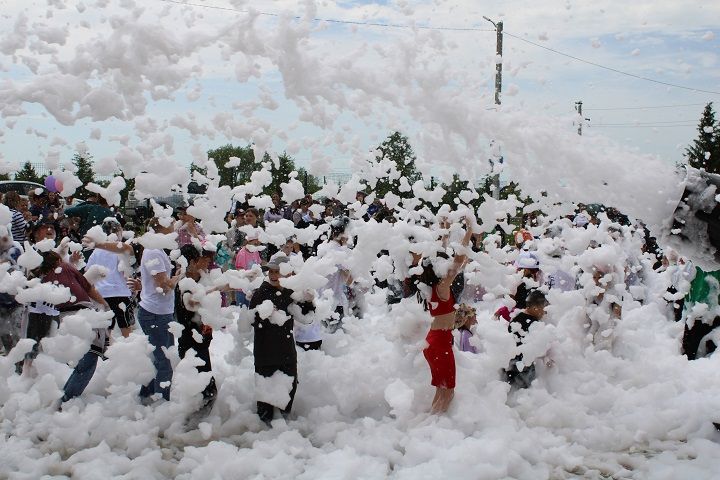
[0,163,720,478]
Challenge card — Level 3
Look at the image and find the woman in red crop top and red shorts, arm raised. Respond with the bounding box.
[416,220,473,413]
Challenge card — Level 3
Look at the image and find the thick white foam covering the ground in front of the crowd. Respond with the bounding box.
[0,284,720,480]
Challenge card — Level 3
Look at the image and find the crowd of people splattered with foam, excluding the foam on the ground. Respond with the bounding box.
[0,183,720,424]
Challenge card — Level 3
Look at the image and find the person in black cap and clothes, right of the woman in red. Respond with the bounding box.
[503,290,547,388]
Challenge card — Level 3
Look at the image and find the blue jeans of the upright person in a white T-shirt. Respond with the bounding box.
[138,307,175,400]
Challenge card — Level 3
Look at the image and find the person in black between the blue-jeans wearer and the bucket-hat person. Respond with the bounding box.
[175,244,217,411]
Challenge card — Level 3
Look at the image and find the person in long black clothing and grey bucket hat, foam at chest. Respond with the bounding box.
[250,257,314,425]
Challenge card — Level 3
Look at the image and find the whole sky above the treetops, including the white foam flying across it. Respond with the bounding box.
[0,0,720,184]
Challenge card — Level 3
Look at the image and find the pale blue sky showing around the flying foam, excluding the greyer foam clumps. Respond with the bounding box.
[0,0,720,182]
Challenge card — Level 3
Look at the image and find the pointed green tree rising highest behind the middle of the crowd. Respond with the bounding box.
[374,132,422,198]
